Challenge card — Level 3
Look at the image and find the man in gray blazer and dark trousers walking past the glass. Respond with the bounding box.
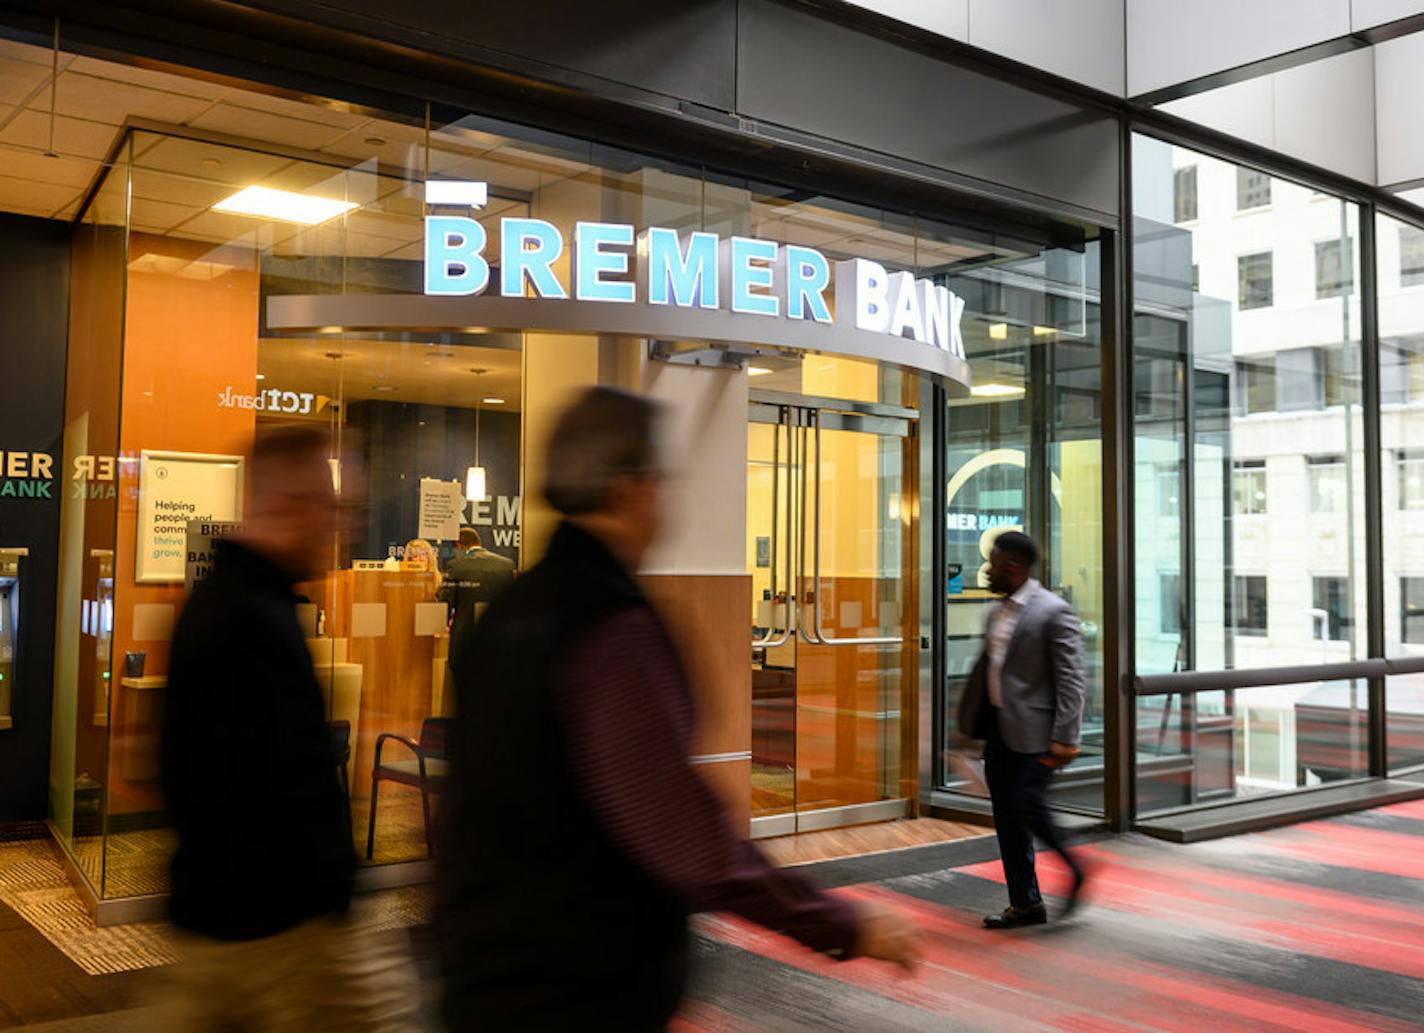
[958,531,1085,929]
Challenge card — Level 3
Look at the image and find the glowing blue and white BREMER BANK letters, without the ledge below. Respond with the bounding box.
[424,182,964,359]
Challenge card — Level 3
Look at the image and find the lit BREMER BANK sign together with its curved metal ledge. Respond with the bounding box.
[266,181,970,396]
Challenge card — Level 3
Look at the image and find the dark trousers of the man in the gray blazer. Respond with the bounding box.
[984,708,1079,908]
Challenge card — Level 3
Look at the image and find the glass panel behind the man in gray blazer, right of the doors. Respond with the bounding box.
[944,242,1105,811]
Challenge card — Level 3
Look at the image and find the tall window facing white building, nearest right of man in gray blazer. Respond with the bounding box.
[1132,135,1368,814]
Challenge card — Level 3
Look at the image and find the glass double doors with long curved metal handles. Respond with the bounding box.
[748,400,918,835]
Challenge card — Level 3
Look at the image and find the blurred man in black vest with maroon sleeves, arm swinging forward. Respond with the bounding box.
[436,388,916,1033]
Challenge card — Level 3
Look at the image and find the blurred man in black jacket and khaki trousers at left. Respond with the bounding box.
[162,427,419,1032]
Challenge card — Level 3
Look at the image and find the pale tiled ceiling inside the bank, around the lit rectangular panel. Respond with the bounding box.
[0,40,1002,269]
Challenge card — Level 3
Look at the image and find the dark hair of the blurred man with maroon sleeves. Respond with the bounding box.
[544,388,658,516]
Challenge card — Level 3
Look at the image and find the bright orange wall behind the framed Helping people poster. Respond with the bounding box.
[110,234,259,812]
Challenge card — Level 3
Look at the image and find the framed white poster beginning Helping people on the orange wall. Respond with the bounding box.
[134,449,242,584]
